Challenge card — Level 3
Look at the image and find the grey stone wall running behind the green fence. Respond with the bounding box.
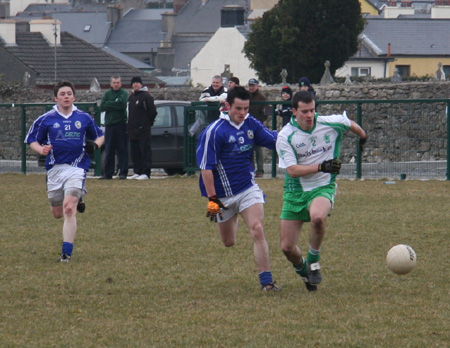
[0,82,450,163]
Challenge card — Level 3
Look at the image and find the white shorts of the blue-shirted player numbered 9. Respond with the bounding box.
[217,184,265,222]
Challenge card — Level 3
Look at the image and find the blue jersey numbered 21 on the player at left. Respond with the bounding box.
[25,105,103,170]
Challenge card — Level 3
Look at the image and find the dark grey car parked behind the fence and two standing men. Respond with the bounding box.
[39,100,206,175]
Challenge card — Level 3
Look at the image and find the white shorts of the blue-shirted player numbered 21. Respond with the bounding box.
[47,164,86,206]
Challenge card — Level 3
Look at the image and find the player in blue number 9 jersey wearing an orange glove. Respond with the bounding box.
[197,86,280,291]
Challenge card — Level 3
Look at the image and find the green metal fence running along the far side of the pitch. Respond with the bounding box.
[0,99,450,180]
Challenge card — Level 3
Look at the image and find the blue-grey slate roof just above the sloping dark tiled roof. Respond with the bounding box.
[106,9,167,53]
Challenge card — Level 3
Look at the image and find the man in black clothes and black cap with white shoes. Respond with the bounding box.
[128,76,158,180]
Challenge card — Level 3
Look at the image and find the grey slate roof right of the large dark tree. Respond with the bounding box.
[363,18,450,56]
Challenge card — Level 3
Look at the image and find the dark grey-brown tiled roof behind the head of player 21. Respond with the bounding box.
[0,32,164,86]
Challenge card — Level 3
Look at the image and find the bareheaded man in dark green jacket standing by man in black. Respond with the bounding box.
[100,76,128,180]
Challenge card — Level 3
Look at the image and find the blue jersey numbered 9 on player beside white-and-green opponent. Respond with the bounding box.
[197,113,277,198]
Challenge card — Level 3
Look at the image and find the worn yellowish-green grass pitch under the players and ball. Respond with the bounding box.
[0,174,450,348]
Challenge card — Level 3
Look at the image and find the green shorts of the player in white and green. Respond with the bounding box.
[280,184,337,221]
